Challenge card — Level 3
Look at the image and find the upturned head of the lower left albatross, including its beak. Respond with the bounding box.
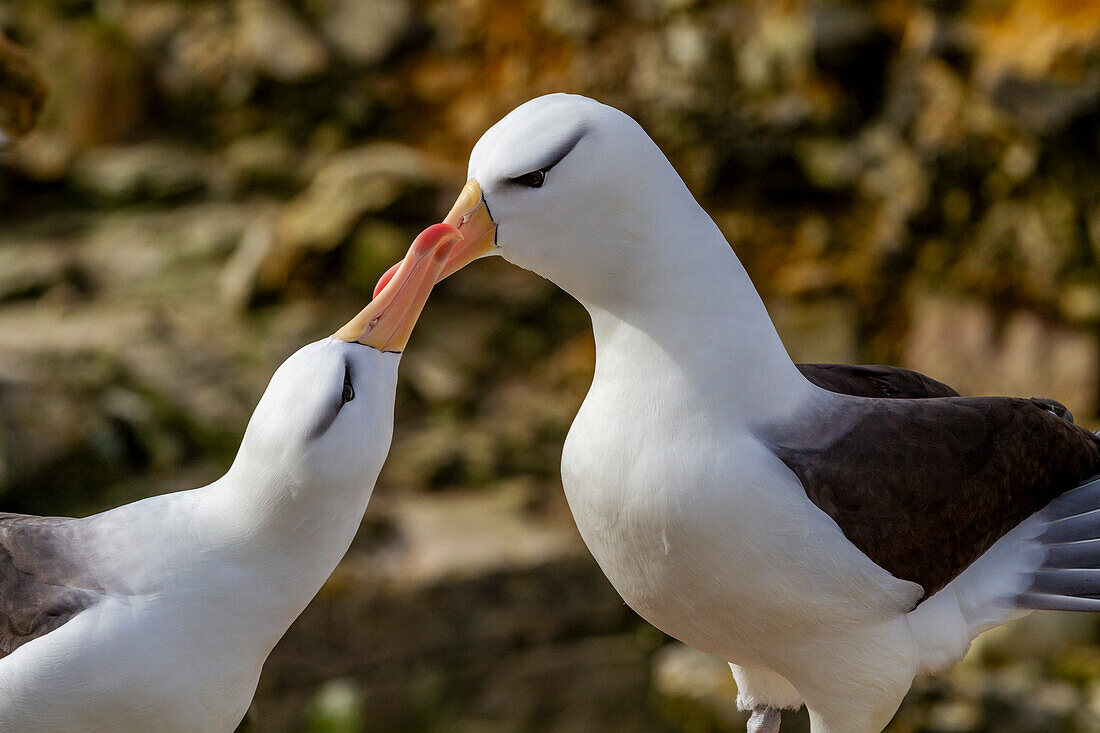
[231,223,461,496]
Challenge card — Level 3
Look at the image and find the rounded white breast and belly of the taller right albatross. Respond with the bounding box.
[562,378,913,666]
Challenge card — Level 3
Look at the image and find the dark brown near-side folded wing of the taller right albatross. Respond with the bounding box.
[766,397,1100,598]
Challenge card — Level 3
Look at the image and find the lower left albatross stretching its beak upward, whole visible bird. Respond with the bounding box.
[0,225,459,733]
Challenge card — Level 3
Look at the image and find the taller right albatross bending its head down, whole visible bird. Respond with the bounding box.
[407,95,1100,733]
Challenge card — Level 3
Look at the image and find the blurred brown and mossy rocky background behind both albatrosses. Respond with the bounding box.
[0,0,1100,733]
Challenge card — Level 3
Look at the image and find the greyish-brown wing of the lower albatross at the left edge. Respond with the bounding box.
[0,514,100,658]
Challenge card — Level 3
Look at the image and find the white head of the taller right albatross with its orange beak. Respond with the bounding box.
[429,94,712,307]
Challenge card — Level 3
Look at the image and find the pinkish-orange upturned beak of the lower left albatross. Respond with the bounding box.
[332,223,463,352]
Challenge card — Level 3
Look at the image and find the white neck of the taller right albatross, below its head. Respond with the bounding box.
[574,200,814,422]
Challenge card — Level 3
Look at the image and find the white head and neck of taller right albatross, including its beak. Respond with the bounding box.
[396,94,809,417]
